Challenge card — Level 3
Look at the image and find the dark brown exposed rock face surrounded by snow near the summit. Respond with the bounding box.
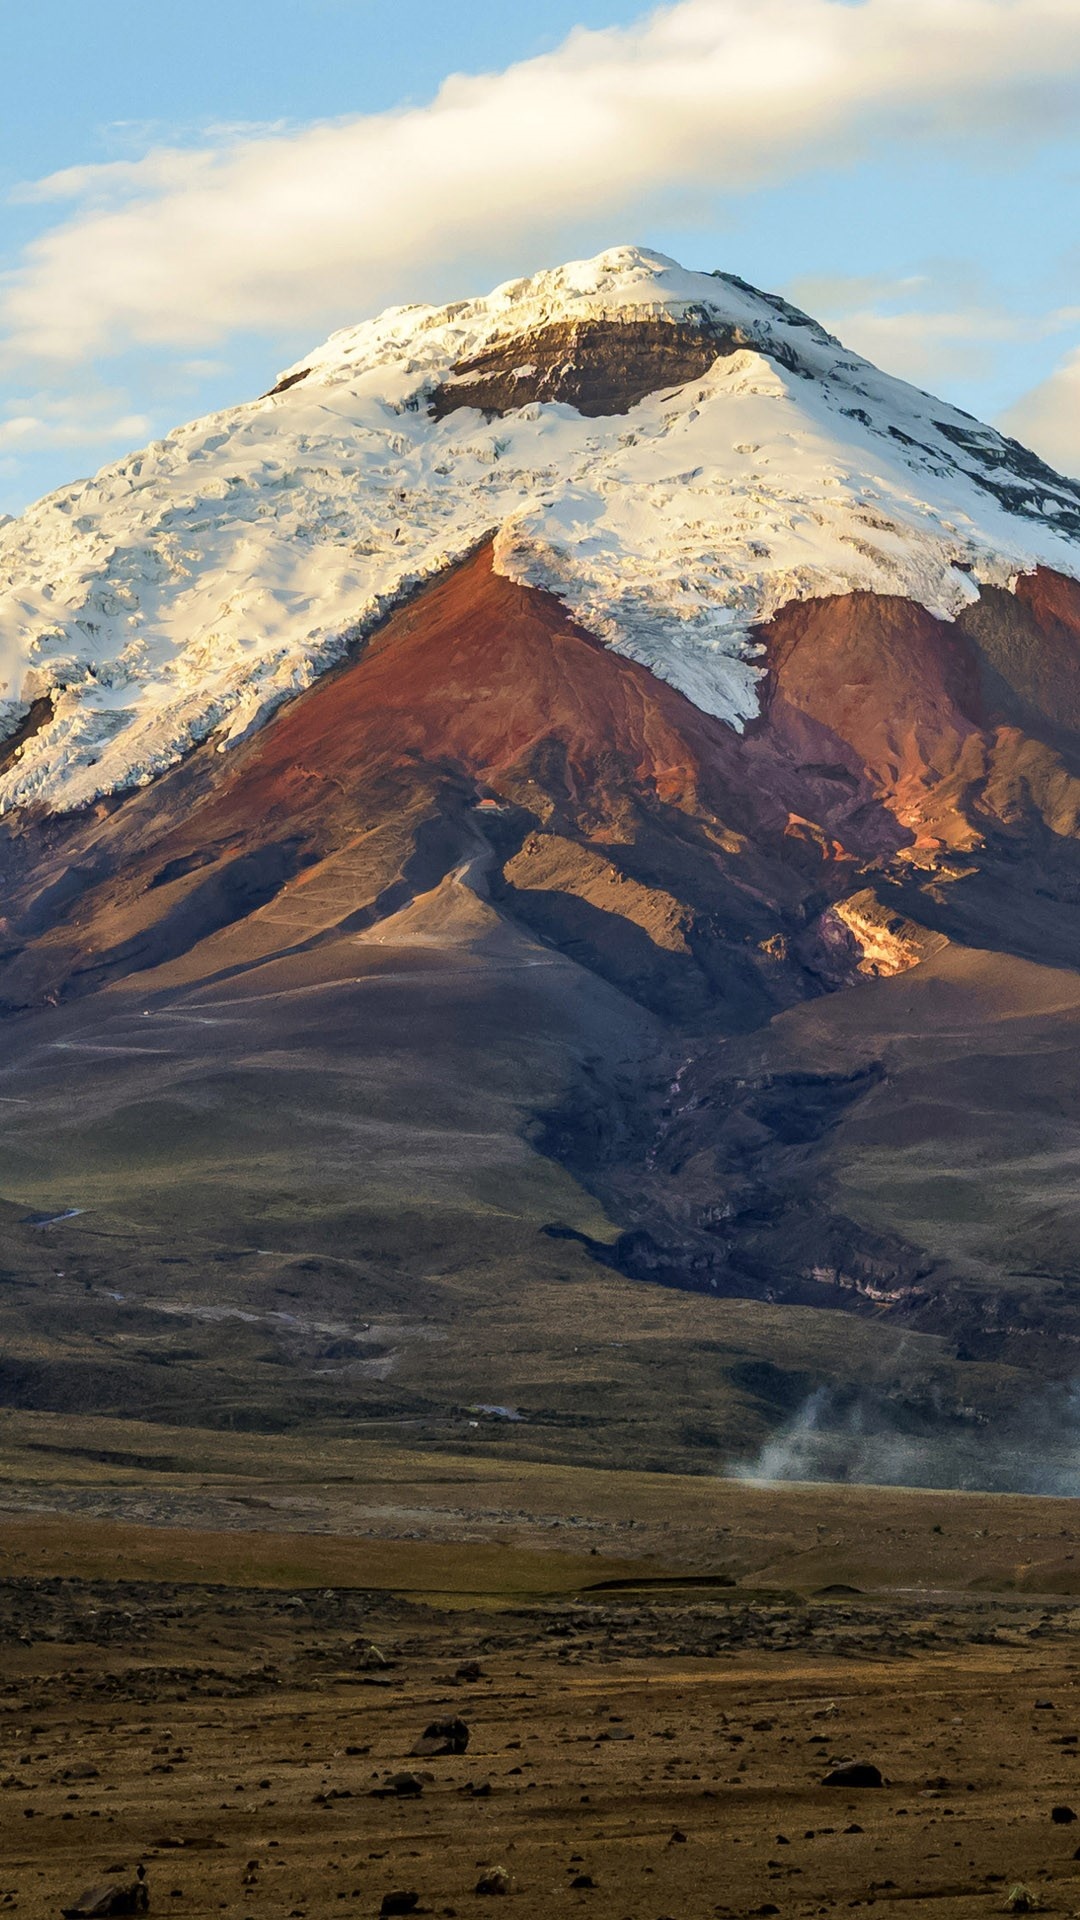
[430,319,740,420]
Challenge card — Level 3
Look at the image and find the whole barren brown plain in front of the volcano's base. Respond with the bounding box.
[0,1459,1080,1920]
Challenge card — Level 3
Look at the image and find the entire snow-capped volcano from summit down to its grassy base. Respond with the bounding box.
[0,248,1080,1488]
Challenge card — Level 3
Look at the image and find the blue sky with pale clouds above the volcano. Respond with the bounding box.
[0,0,1080,513]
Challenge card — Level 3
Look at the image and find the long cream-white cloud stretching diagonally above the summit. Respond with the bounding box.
[0,0,1080,363]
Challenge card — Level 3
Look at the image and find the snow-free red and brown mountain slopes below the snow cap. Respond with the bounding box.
[0,549,1080,1474]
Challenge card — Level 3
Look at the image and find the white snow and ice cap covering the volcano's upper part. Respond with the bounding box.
[0,248,1080,810]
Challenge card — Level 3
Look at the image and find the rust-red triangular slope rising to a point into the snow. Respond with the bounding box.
[174,547,903,854]
